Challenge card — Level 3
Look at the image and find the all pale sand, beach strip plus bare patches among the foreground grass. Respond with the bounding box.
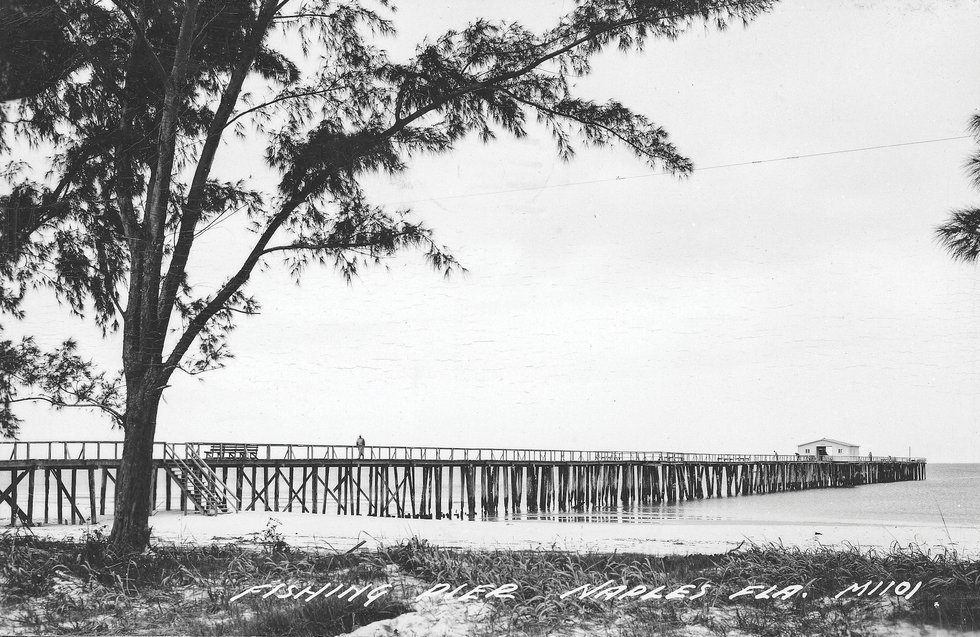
[13,512,980,637]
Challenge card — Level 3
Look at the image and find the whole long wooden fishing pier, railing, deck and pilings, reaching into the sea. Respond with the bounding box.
[0,441,926,526]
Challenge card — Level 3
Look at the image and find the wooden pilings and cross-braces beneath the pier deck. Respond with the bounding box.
[0,446,926,524]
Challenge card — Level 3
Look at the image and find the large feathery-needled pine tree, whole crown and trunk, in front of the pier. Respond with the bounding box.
[0,0,772,550]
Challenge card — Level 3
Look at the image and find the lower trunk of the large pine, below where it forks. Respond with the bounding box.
[109,392,160,552]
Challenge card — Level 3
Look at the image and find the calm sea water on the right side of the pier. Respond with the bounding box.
[498,464,980,527]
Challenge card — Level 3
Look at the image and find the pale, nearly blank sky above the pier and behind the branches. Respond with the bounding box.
[11,0,980,462]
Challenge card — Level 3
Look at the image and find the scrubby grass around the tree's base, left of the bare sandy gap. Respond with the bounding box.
[0,528,409,635]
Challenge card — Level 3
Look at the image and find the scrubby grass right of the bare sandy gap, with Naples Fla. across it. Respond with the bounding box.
[387,542,980,635]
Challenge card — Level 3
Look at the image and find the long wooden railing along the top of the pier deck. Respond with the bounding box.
[0,440,926,463]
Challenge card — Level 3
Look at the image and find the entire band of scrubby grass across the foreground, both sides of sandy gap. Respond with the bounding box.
[0,527,980,636]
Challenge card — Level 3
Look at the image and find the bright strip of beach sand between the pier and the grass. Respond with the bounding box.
[23,511,980,557]
